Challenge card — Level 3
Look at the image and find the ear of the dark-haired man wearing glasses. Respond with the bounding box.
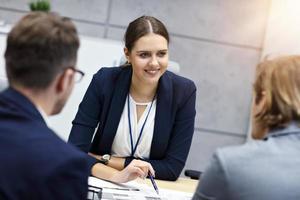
[56,69,74,94]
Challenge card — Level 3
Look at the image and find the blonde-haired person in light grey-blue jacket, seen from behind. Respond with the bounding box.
[193,56,300,200]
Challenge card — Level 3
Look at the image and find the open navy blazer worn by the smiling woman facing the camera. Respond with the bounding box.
[69,66,196,180]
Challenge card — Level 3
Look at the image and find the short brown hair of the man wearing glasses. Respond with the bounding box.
[5,12,79,89]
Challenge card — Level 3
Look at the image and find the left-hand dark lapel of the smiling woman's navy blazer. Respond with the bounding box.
[99,67,132,154]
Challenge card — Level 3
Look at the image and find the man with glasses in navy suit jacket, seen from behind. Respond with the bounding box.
[0,12,91,200]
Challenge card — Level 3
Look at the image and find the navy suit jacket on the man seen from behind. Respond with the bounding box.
[0,88,90,200]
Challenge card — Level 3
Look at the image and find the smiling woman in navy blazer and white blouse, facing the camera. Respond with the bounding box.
[69,16,196,182]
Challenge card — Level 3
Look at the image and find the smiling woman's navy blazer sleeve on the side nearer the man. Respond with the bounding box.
[68,70,102,153]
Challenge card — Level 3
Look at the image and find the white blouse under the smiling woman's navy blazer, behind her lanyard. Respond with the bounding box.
[112,95,156,159]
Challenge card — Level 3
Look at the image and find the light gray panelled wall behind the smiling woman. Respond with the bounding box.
[0,0,270,173]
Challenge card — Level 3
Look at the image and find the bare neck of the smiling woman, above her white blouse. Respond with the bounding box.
[130,78,158,103]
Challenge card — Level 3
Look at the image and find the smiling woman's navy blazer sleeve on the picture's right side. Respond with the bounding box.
[125,82,196,181]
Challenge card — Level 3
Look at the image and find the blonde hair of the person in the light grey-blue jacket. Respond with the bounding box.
[254,56,300,129]
